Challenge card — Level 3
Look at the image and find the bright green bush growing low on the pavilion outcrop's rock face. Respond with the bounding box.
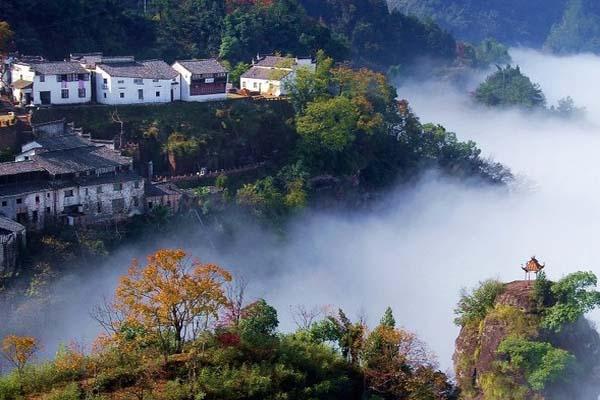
[498,335,575,391]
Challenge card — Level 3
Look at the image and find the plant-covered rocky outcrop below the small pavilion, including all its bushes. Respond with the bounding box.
[454,272,600,400]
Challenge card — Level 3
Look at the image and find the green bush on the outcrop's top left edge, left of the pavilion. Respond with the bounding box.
[454,280,504,326]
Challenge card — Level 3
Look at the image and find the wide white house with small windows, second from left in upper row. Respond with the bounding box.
[94,57,181,104]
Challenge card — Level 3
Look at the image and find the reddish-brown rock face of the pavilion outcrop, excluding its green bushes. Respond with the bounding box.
[453,281,600,400]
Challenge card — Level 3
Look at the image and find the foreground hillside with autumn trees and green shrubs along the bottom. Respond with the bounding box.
[0,249,458,400]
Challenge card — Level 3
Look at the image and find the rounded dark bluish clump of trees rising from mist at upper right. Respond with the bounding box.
[475,65,546,108]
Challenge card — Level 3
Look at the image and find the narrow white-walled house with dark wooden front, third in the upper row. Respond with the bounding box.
[173,59,228,101]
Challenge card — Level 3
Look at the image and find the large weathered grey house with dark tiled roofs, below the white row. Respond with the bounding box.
[0,121,144,230]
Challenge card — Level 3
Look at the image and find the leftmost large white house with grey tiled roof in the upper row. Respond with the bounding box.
[10,61,92,105]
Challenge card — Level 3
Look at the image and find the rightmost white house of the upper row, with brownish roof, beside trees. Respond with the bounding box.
[240,56,316,96]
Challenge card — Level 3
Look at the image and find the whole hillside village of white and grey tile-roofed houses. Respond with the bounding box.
[0,53,315,273]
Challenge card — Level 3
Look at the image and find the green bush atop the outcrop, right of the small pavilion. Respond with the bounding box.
[541,271,600,332]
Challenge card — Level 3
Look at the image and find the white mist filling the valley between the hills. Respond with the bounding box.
[0,49,600,369]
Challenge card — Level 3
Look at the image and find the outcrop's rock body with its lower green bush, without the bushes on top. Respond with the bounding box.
[453,281,600,400]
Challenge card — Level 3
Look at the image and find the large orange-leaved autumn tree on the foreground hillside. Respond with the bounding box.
[114,249,231,352]
